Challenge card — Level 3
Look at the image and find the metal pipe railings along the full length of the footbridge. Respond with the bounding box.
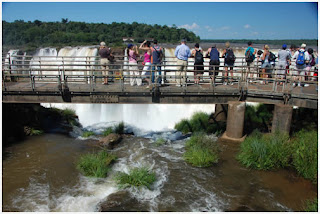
[2,53,318,97]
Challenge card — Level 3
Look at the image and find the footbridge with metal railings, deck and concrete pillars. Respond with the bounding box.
[2,53,318,138]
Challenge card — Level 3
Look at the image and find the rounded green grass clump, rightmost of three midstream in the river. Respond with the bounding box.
[183,133,218,167]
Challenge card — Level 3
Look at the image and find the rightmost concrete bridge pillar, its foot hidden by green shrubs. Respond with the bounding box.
[271,104,293,133]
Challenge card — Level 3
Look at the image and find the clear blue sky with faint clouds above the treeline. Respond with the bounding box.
[2,1,318,39]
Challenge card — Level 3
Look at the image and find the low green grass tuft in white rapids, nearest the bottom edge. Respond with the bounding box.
[116,167,156,189]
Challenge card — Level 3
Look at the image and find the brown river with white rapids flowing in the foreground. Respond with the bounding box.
[3,124,317,212]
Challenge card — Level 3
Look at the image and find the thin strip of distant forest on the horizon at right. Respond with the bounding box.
[201,39,318,47]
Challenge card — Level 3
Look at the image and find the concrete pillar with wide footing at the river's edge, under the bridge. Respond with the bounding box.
[226,101,246,139]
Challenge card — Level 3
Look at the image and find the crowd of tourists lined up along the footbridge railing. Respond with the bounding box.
[99,39,318,88]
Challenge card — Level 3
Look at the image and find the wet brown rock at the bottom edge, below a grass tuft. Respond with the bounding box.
[97,190,146,212]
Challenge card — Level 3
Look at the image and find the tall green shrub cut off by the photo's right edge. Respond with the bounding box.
[292,130,318,182]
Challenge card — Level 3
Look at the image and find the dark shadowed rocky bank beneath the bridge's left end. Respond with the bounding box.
[2,103,80,146]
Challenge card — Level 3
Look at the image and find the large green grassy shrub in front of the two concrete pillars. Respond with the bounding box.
[237,131,290,170]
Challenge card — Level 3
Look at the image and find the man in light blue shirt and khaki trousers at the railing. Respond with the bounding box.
[174,39,191,87]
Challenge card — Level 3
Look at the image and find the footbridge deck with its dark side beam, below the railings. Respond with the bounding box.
[3,81,318,108]
